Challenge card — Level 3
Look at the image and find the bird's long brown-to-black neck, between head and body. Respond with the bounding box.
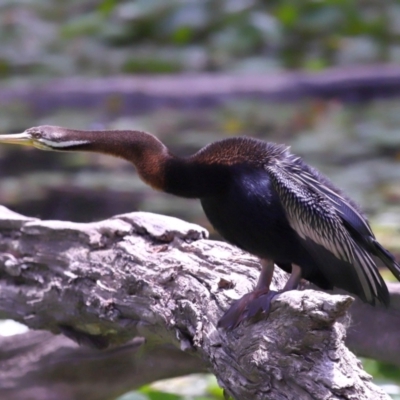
[59,130,225,198]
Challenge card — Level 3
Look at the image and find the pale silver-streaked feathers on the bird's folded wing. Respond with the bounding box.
[265,165,386,303]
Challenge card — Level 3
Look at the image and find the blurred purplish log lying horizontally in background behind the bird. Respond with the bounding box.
[0,64,400,115]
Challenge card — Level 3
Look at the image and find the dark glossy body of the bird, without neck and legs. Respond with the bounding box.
[165,138,399,304]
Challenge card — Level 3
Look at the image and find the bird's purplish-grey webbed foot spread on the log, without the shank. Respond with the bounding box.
[218,289,278,330]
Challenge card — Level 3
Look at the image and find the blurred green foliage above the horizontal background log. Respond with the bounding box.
[0,0,400,77]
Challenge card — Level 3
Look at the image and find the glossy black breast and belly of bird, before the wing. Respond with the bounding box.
[201,170,299,262]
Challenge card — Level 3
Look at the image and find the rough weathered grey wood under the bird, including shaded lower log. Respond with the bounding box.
[0,207,389,400]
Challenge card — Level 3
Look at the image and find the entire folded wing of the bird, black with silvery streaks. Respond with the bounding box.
[266,165,390,304]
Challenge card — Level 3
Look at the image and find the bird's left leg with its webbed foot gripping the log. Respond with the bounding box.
[218,259,274,329]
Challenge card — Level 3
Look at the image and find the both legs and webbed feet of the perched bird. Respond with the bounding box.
[218,259,301,330]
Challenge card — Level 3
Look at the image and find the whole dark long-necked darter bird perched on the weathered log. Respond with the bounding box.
[0,126,400,329]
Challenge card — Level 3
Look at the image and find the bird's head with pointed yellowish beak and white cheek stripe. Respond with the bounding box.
[0,125,90,151]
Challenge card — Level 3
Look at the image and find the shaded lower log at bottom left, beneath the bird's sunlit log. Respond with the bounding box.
[0,331,206,400]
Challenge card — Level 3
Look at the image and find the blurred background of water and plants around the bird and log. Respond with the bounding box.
[0,0,400,400]
